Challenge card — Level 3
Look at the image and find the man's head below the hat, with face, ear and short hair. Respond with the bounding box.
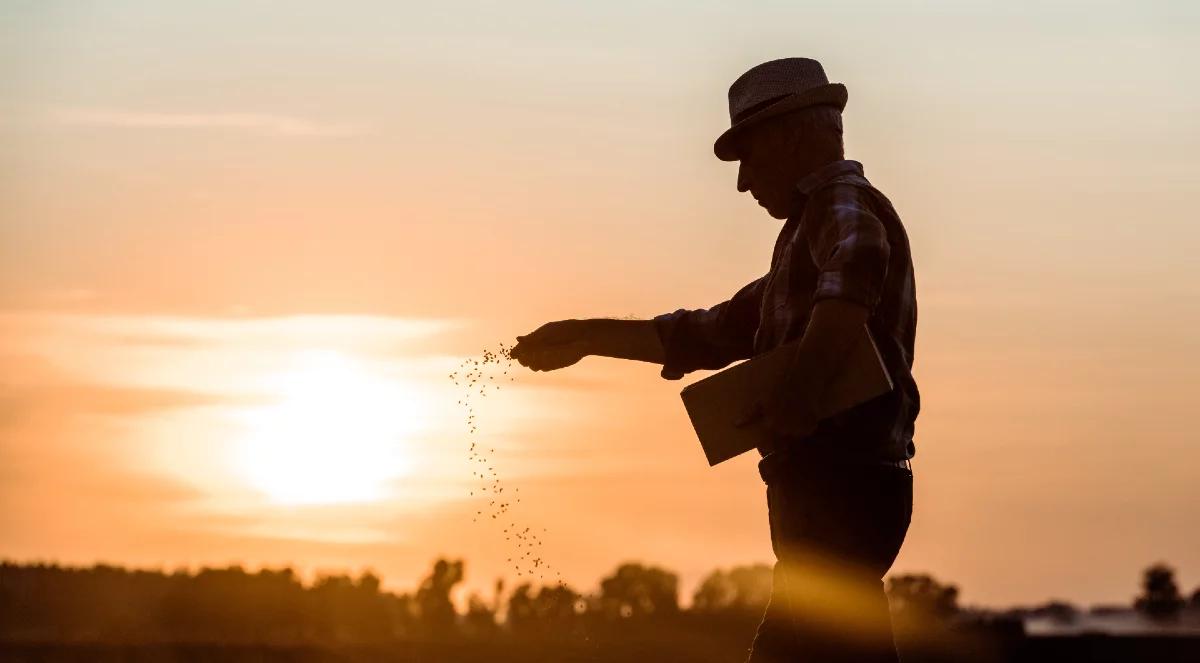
[732,106,845,219]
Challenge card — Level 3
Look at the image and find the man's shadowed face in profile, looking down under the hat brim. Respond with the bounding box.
[737,123,796,220]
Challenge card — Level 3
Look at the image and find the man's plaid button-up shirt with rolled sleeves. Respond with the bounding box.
[654,160,920,460]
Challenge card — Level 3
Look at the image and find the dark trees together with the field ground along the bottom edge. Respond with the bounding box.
[0,560,1200,662]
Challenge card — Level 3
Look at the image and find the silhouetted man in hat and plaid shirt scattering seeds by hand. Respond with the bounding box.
[512,58,919,663]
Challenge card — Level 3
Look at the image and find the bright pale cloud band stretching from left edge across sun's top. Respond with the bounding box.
[0,311,464,403]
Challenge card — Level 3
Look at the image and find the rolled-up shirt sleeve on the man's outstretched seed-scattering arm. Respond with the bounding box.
[654,276,767,380]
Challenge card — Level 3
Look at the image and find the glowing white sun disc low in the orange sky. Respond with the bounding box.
[236,351,424,504]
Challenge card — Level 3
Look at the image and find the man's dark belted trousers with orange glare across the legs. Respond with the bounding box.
[749,453,912,663]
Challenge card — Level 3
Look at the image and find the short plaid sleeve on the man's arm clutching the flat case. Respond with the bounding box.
[805,184,890,311]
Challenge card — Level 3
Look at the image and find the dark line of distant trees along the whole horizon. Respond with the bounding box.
[0,559,1200,644]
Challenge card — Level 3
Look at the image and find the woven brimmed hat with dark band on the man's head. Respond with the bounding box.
[713,58,847,161]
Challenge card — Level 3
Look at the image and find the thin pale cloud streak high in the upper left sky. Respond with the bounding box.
[50,108,364,138]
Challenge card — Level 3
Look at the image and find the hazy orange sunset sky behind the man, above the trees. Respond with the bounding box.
[0,2,1200,604]
